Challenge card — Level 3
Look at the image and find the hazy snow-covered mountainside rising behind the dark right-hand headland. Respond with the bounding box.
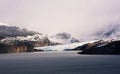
[80,24,120,41]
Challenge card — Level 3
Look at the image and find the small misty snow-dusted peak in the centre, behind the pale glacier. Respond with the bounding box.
[49,32,79,44]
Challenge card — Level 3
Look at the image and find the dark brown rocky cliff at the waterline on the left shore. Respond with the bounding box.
[0,42,34,53]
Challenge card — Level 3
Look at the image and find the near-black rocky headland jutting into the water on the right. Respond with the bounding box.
[74,41,120,54]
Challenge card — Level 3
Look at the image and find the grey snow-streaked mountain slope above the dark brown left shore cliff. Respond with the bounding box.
[0,23,50,46]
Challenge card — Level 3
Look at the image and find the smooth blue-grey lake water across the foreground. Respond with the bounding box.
[0,51,120,74]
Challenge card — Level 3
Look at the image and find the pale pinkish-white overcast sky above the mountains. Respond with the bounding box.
[0,0,120,36]
